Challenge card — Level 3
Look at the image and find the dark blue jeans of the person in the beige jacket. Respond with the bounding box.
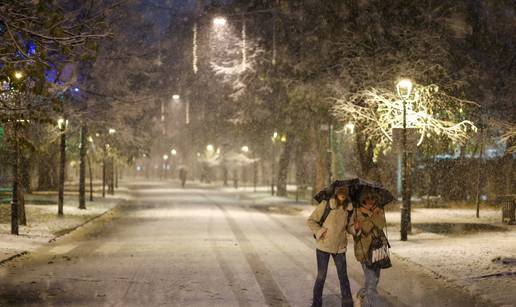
[312,249,353,307]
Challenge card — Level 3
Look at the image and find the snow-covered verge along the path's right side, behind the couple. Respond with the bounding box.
[232,189,516,306]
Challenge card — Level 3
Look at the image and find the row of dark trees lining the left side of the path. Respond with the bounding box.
[0,0,160,234]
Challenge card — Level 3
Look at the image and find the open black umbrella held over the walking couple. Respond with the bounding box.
[314,178,394,207]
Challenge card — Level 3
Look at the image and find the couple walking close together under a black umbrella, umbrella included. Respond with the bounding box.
[307,178,394,307]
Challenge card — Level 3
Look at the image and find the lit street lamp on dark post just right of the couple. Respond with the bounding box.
[396,79,412,241]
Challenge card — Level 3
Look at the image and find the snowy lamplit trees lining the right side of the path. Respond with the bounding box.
[167,0,516,200]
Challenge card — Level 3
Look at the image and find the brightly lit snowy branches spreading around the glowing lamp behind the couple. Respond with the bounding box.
[332,85,477,149]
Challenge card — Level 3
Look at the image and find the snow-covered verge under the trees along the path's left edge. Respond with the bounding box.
[0,188,129,262]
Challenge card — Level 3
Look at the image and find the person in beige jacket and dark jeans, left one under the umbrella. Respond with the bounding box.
[307,187,353,307]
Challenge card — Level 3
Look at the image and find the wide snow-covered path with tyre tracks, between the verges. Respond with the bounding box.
[0,182,494,307]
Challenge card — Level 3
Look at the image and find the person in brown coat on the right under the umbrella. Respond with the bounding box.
[349,193,388,307]
